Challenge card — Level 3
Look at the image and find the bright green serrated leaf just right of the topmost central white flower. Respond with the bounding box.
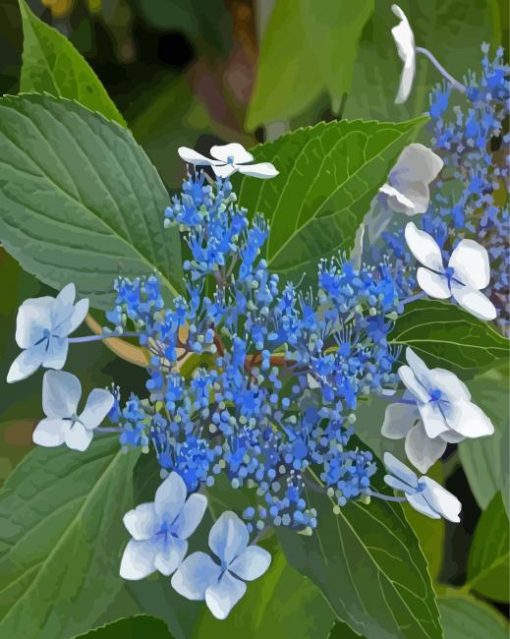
[237,117,427,278]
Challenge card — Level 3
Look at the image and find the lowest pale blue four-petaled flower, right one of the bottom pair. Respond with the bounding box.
[172,511,271,619]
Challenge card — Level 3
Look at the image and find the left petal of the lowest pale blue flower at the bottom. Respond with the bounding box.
[171,552,221,601]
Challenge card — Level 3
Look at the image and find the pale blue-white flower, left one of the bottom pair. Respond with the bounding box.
[120,472,207,580]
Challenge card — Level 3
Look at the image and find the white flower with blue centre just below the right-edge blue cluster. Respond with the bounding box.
[405,222,497,320]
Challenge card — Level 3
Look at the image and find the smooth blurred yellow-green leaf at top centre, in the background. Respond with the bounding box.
[246,0,323,131]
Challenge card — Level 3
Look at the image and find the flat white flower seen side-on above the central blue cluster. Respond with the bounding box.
[177,142,278,180]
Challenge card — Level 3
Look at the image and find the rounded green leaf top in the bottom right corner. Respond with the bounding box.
[437,591,509,639]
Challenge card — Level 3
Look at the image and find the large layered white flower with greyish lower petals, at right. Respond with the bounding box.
[381,348,494,473]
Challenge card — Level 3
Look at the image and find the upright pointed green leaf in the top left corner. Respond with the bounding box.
[19,0,126,126]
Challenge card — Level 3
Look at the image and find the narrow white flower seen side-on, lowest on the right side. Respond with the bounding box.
[384,453,462,523]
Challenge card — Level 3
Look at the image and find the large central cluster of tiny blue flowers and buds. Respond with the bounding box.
[108,173,402,531]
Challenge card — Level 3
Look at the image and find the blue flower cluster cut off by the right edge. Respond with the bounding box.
[384,45,510,331]
